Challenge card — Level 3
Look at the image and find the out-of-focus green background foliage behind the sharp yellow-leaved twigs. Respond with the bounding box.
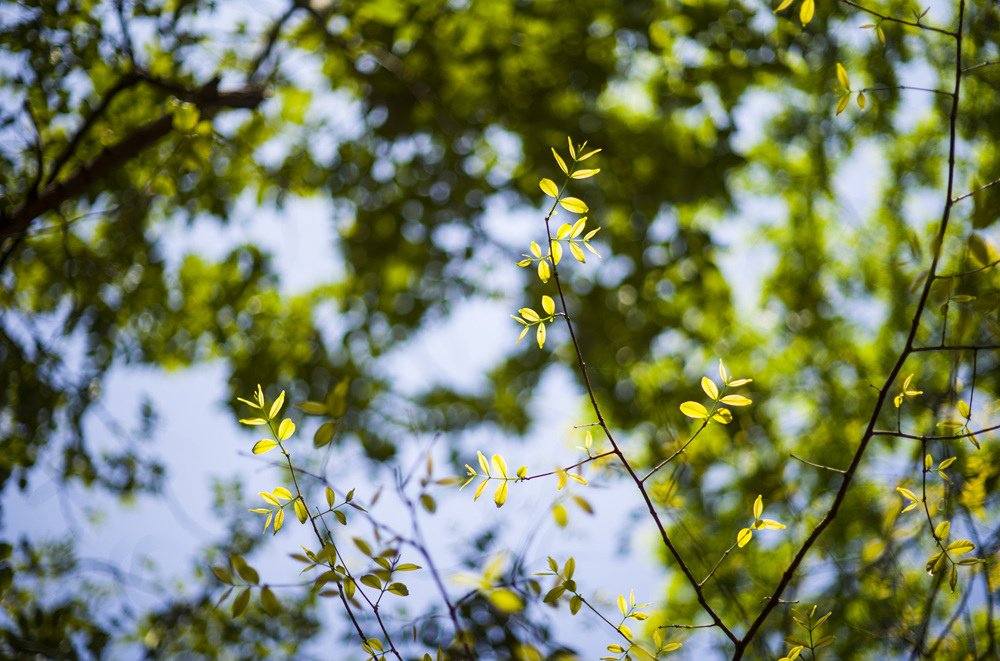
[0,0,1000,658]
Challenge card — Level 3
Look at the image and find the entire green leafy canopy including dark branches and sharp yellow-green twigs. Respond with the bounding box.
[0,0,1000,659]
